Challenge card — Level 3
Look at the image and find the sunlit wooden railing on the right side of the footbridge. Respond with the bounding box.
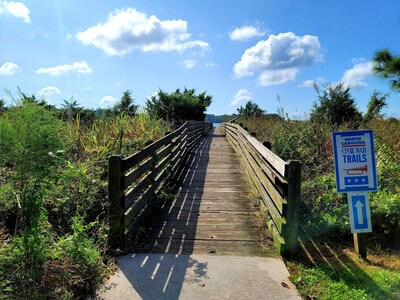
[221,123,301,256]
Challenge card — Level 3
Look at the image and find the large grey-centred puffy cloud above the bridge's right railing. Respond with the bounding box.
[233,32,323,86]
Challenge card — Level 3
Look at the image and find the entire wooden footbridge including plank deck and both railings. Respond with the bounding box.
[109,121,300,256]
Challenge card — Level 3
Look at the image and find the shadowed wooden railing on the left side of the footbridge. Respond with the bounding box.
[108,121,212,248]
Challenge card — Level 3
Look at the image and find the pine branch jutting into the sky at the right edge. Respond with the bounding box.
[372,48,400,92]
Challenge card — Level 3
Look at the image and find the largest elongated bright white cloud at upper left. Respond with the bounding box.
[75,8,209,55]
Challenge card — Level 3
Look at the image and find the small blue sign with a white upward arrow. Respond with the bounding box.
[347,192,372,233]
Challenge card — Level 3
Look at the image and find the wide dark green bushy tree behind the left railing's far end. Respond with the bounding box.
[146,88,212,124]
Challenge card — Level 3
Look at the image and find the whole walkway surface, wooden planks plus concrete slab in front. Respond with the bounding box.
[97,127,300,299]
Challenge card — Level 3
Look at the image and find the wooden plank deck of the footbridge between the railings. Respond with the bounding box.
[140,128,271,256]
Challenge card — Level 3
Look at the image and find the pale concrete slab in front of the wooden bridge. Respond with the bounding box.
[96,254,301,300]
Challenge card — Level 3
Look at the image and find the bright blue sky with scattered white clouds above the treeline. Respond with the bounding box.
[0,0,400,118]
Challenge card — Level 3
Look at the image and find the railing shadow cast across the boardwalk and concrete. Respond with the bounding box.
[104,130,214,299]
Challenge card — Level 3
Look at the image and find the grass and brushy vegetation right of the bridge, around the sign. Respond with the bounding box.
[238,114,400,300]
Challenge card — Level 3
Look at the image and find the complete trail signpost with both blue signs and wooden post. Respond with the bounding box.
[333,130,378,258]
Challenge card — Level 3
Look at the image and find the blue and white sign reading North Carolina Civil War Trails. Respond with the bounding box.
[332,130,378,193]
